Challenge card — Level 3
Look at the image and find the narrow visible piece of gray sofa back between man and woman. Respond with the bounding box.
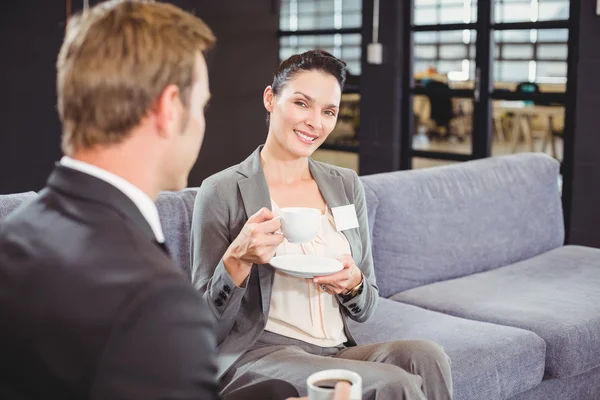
[156,188,198,280]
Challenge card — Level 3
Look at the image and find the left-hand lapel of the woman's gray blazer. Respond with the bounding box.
[238,146,274,317]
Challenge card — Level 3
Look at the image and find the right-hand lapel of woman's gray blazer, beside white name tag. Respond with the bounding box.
[308,159,362,262]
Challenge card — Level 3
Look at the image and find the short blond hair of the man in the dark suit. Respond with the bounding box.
[56,0,215,154]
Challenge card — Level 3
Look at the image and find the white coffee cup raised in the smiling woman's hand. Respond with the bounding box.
[278,207,321,243]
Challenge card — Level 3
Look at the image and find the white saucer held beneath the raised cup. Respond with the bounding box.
[269,255,344,278]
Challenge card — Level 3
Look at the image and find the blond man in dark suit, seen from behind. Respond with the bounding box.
[0,1,223,399]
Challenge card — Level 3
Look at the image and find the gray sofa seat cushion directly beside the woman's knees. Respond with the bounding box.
[349,298,545,400]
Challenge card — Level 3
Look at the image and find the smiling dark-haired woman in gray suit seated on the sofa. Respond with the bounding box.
[191,50,452,400]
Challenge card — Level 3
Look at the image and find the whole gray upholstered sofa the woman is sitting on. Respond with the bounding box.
[0,154,600,400]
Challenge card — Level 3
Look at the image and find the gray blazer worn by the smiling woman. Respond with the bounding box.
[191,146,379,376]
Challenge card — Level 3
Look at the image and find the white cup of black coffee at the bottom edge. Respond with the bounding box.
[306,369,362,400]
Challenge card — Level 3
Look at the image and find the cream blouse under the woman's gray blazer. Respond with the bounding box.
[265,199,350,347]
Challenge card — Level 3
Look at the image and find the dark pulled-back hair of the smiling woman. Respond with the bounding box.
[267,50,346,122]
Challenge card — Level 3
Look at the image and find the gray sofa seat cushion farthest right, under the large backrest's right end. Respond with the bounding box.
[392,246,600,378]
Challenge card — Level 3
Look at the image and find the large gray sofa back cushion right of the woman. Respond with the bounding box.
[361,153,564,297]
